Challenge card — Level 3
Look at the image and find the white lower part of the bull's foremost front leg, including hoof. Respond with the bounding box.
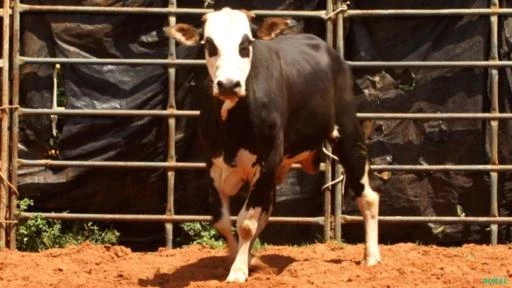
[226,206,261,283]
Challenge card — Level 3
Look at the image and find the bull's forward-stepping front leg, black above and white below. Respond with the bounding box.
[226,155,277,283]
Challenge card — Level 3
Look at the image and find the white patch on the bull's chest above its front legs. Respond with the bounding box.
[210,149,260,196]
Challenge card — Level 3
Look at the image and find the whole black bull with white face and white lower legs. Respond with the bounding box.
[169,8,380,282]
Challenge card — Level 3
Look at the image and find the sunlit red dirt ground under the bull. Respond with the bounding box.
[0,243,512,288]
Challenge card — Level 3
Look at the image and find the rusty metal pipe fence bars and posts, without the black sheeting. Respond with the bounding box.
[0,0,512,249]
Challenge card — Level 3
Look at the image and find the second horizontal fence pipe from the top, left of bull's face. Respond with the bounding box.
[18,56,206,67]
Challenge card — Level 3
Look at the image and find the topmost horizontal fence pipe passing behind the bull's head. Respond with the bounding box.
[19,4,326,18]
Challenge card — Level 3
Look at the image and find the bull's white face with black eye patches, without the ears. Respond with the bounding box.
[203,8,254,102]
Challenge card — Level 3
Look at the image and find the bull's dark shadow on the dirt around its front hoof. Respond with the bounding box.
[138,254,296,288]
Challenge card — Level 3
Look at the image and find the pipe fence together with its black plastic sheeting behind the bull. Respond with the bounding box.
[0,0,512,250]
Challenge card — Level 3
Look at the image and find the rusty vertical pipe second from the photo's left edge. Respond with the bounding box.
[9,0,20,249]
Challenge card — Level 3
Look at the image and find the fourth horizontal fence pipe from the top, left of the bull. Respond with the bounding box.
[18,159,206,169]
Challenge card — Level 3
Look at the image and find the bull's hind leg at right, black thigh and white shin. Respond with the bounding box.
[333,134,381,266]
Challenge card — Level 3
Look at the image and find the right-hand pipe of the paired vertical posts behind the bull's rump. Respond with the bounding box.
[334,0,346,242]
